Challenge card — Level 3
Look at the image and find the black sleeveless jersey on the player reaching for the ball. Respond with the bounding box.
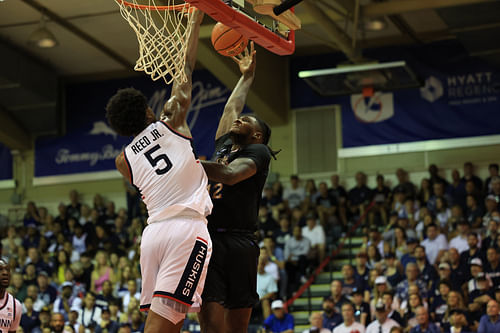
[207,134,271,232]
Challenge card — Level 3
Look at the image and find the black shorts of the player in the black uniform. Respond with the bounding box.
[202,232,260,309]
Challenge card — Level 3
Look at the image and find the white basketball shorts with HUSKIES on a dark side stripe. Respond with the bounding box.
[140,216,212,312]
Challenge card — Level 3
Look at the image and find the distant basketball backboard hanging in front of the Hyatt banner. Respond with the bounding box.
[299,61,422,96]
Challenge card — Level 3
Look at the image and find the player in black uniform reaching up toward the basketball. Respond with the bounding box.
[200,43,271,333]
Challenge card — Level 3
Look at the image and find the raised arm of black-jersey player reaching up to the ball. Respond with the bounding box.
[215,42,256,140]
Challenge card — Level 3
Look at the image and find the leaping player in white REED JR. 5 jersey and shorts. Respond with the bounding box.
[106,11,212,333]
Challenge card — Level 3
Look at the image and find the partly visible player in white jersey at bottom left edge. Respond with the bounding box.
[0,259,23,332]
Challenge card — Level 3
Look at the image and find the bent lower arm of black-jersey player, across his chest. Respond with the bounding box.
[201,157,257,185]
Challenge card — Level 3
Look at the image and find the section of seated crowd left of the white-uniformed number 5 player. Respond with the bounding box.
[1,184,147,333]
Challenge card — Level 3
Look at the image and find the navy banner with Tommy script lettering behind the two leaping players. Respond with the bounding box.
[35,70,249,177]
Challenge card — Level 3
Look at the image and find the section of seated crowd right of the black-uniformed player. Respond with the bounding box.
[254,162,500,333]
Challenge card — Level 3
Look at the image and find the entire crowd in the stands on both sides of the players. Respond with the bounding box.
[1,163,500,333]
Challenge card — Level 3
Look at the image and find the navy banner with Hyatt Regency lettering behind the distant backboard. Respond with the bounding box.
[291,43,500,148]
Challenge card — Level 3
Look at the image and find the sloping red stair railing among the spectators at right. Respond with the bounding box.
[285,201,375,312]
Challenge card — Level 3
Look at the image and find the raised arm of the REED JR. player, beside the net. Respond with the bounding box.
[160,10,203,136]
